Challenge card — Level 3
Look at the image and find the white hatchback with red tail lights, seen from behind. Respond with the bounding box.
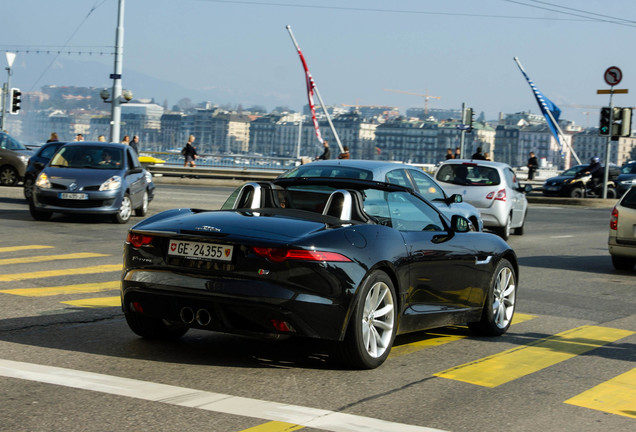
[435,159,528,240]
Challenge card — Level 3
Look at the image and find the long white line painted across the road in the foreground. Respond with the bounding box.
[0,359,443,432]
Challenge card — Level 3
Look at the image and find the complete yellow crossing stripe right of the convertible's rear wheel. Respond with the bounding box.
[434,326,634,387]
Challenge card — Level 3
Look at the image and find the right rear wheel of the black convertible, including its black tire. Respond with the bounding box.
[338,270,398,369]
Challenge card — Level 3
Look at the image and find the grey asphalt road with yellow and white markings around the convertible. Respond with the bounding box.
[0,183,636,432]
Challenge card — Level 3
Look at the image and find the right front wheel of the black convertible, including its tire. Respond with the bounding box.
[468,259,517,336]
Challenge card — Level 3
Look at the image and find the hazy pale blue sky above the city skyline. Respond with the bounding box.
[0,0,636,126]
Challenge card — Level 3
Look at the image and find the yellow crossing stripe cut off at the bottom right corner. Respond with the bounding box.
[565,369,636,419]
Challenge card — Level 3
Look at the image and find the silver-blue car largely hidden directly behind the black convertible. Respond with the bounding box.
[281,159,484,231]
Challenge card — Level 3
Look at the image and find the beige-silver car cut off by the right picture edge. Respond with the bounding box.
[608,186,636,270]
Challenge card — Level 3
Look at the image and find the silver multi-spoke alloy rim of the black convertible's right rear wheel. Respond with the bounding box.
[362,282,395,358]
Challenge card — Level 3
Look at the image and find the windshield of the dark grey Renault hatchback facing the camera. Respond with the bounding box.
[51,145,123,170]
